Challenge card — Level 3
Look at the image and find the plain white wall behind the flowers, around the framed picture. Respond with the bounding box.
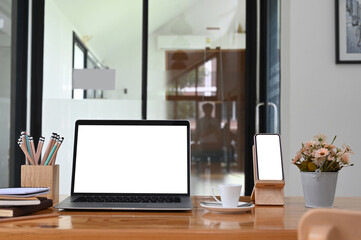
[281,0,361,196]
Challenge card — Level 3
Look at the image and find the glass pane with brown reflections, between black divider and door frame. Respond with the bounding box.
[147,0,246,195]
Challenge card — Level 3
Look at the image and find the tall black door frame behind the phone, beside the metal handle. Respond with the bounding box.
[245,0,280,196]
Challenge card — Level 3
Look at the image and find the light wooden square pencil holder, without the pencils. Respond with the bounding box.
[21,165,59,204]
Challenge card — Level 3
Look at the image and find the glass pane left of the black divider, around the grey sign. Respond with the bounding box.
[42,0,142,194]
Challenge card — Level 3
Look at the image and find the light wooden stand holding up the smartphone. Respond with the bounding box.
[251,146,285,206]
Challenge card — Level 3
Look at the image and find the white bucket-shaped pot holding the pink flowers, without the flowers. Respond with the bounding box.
[300,172,338,208]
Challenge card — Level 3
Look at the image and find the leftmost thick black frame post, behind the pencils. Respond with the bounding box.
[9,0,29,187]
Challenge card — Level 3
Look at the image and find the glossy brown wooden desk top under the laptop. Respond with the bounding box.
[0,197,361,240]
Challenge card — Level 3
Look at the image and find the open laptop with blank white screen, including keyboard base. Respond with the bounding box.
[55,120,192,210]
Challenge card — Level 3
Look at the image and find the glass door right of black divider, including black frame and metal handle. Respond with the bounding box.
[147,0,280,195]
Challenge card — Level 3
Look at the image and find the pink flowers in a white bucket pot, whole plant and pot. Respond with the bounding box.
[292,134,353,208]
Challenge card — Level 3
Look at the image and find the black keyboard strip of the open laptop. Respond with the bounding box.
[74,196,180,203]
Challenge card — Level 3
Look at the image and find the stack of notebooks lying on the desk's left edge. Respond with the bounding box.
[0,188,53,217]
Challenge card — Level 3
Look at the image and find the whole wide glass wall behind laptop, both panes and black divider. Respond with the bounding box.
[33,0,279,195]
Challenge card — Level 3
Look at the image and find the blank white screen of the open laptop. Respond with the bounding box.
[74,125,188,194]
